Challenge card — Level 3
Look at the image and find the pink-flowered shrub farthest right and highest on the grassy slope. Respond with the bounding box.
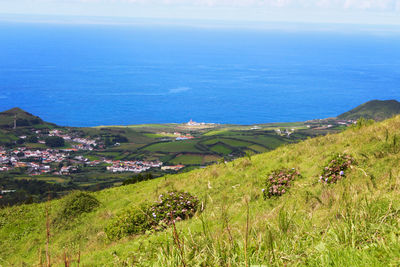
[319,154,355,184]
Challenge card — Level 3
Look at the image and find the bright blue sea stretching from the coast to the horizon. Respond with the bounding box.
[0,22,400,126]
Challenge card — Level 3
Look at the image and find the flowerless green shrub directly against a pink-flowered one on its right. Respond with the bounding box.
[105,205,155,240]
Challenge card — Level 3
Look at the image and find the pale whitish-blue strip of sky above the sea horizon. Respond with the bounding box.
[0,0,400,25]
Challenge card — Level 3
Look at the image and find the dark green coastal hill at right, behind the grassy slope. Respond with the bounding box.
[337,100,400,121]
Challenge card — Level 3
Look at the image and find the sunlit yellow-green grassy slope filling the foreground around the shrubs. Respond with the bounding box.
[0,116,400,266]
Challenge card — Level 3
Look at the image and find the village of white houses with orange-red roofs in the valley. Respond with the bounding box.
[0,130,184,176]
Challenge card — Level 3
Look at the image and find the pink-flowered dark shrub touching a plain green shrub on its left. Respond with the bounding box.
[150,191,199,227]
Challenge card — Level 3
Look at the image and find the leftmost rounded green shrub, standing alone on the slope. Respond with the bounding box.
[59,191,100,219]
